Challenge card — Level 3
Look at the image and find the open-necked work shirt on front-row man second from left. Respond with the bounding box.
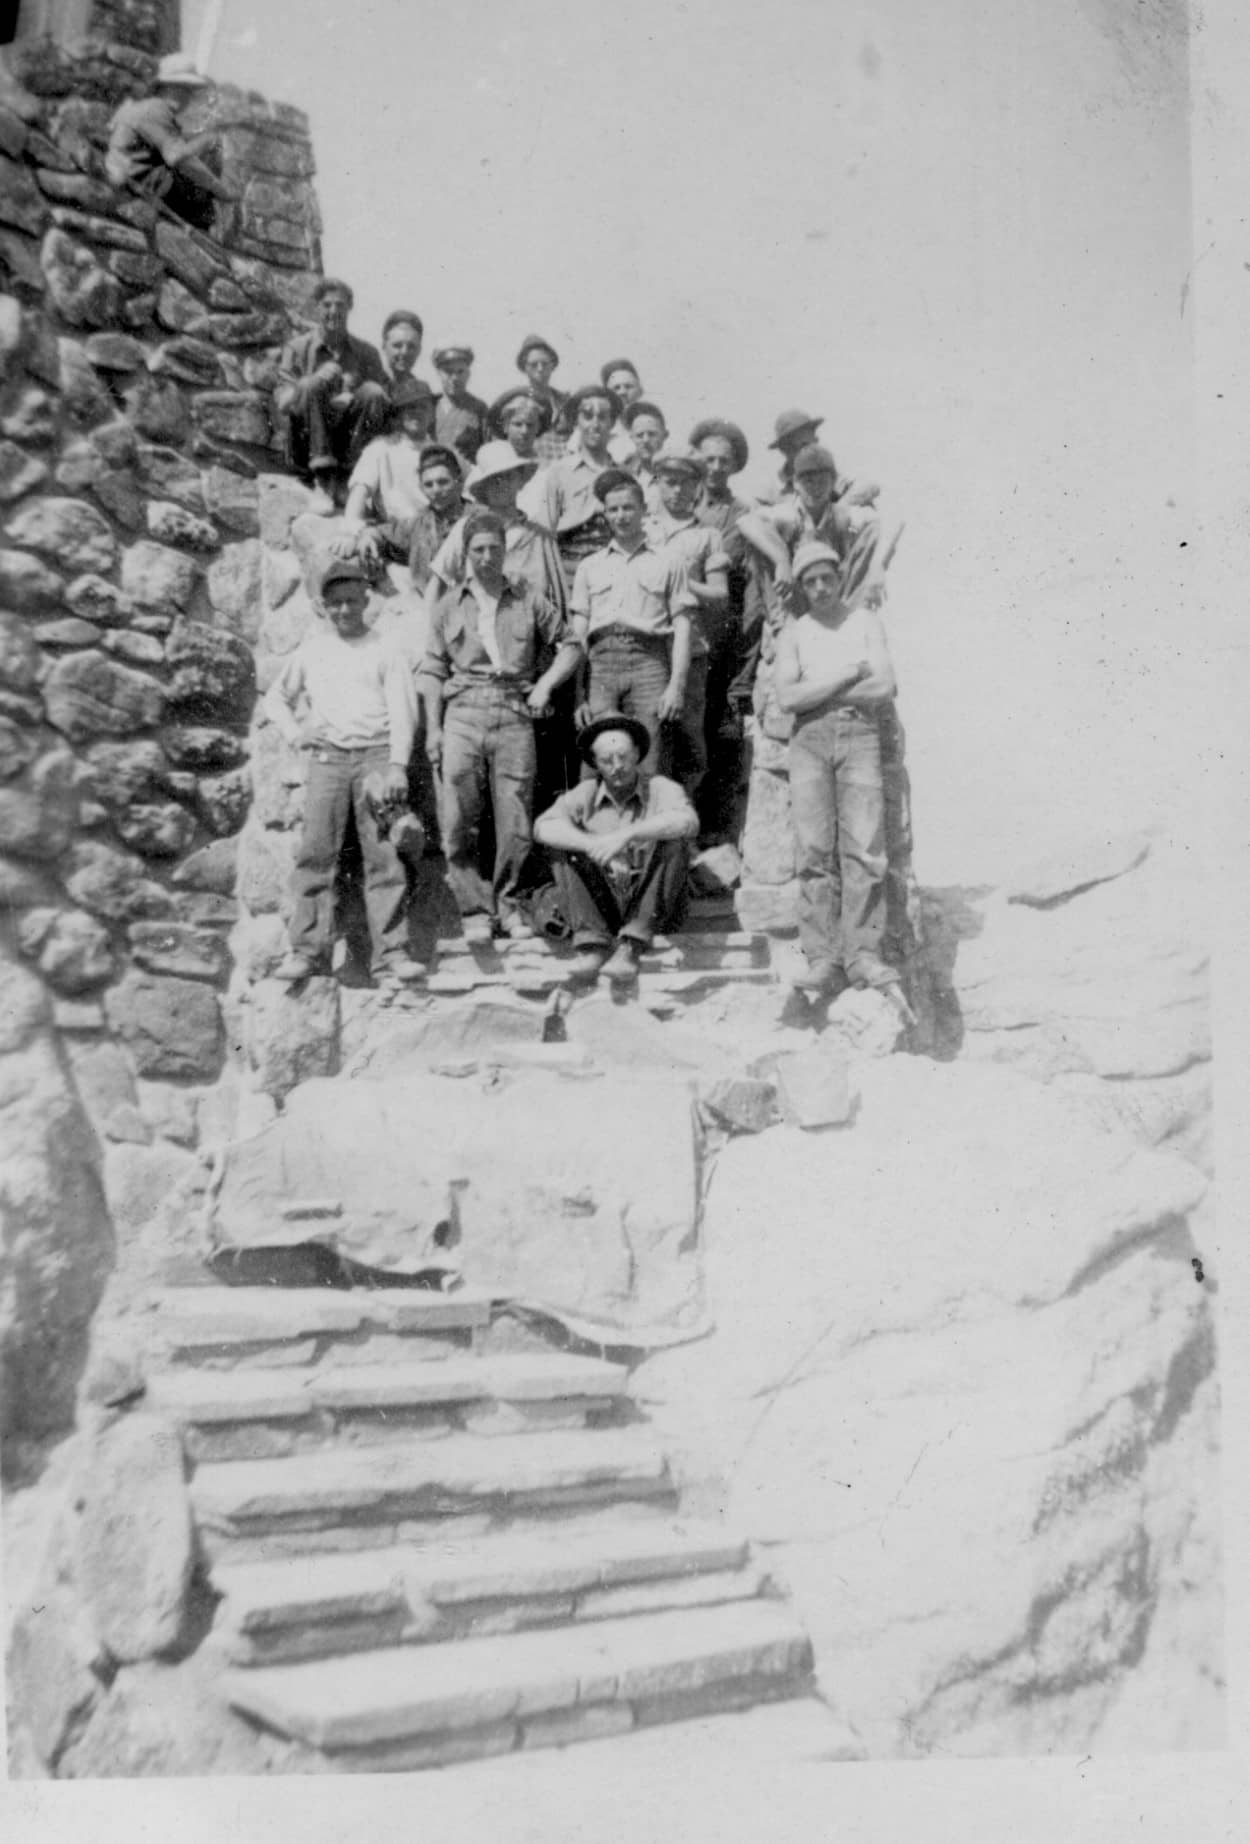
[420,577,575,699]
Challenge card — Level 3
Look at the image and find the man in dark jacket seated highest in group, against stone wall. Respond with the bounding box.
[273,275,391,516]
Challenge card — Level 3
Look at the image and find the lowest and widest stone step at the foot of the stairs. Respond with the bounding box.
[221,1601,811,1770]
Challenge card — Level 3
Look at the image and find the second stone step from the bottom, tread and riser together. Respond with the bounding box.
[212,1521,765,1665]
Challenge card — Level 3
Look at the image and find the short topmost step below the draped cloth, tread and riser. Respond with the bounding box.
[149,1285,490,1368]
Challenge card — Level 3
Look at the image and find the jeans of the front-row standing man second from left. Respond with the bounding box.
[442,684,537,916]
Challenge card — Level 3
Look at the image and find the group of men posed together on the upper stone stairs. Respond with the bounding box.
[267,278,907,996]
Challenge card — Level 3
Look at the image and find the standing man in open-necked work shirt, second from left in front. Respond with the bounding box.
[420,511,581,946]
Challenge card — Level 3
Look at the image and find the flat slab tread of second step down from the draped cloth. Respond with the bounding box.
[149,1352,627,1424]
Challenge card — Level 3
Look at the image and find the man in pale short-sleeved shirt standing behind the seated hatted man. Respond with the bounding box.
[570,468,699,773]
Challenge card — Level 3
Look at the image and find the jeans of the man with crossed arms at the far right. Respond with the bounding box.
[789,704,894,987]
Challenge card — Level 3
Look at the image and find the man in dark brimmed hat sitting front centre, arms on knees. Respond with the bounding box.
[535,712,699,987]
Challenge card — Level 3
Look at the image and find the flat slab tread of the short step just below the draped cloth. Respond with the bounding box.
[155,1287,490,1350]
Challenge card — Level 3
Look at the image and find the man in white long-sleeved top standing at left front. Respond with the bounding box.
[265,557,426,985]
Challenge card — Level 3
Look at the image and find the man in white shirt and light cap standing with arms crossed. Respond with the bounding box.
[774,540,898,996]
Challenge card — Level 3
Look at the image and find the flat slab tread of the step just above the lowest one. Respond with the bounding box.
[212,1521,747,1634]
